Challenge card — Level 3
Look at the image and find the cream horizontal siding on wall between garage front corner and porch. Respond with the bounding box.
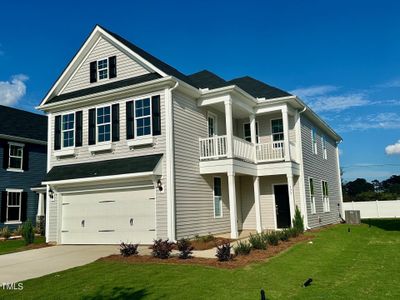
[173,93,230,238]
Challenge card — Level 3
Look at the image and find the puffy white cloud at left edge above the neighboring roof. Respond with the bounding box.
[0,74,29,106]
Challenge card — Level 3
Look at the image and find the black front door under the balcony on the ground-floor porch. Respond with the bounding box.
[274,184,290,228]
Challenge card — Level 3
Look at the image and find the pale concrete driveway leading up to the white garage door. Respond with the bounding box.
[0,245,119,284]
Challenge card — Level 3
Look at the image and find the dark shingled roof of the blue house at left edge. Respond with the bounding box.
[0,105,47,142]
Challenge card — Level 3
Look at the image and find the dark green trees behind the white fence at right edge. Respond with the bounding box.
[342,175,400,202]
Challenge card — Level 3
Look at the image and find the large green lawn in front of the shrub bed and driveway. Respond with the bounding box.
[0,220,400,300]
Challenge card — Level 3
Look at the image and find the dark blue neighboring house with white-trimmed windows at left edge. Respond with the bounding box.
[0,105,47,229]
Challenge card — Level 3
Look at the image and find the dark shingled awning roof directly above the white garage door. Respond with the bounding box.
[43,154,162,182]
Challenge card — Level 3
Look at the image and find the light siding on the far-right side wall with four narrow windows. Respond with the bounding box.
[301,115,340,228]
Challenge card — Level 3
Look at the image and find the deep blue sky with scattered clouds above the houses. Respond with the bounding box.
[0,0,400,180]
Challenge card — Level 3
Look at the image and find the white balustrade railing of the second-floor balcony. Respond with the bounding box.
[199,135,285,163]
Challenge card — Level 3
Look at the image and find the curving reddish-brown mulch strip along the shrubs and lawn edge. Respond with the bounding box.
[100,235,314,269]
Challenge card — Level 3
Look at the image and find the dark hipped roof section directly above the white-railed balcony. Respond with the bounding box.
[228,76,292,99]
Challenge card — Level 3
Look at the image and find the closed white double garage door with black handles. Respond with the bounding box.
[61,188,155,244]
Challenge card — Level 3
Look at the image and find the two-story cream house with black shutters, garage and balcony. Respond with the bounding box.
[39,26,342,244]
